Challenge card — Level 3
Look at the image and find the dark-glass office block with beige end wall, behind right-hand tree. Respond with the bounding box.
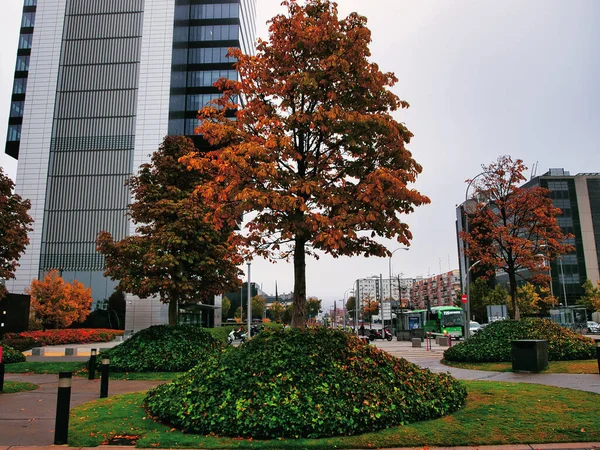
[456,169,600,306]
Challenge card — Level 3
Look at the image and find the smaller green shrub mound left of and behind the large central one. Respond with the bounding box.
[97,325,224,372]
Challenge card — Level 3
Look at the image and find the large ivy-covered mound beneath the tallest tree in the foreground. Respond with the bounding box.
[145,328,467,439]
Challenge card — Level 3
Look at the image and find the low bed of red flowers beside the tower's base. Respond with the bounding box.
[6,328,123,345]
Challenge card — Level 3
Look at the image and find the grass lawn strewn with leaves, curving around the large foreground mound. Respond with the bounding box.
[69,381,600,449]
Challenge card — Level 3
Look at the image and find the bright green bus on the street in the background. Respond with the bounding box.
[406,306,465,339]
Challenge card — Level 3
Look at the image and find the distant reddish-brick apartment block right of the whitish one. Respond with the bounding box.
[409,269,460,309]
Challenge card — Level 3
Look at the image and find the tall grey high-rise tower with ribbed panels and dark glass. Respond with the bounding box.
[5,0,256,330]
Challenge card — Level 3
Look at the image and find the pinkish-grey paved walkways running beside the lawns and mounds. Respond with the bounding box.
[0,340,600,450]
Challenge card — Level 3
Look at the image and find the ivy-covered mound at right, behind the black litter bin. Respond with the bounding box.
[444,319,596,362]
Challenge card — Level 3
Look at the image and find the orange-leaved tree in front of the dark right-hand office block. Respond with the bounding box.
[460,156,573,319]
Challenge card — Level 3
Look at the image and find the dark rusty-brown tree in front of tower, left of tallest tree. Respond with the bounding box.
[97,136,242,325]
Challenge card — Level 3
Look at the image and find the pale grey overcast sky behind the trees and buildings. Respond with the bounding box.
[0,0,600,305]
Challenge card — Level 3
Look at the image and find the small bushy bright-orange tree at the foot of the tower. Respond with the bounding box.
[26,270,92,329]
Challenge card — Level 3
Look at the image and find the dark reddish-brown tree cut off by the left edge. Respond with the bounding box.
[0,167,33,299]
